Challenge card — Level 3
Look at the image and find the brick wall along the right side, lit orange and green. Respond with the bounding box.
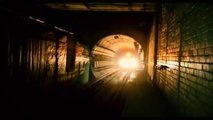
[157,3,213,116]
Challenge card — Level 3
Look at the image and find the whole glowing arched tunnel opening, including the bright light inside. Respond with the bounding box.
[91,34,144,82]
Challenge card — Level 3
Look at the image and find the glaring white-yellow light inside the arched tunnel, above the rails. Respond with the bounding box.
[118,57,138,69]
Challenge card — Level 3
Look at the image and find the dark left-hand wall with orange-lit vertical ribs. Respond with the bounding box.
[1,11,78,89]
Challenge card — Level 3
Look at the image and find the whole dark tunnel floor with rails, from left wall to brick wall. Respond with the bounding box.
[2,71,176,119]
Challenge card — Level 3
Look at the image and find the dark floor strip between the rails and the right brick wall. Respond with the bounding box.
[122,77,176,118]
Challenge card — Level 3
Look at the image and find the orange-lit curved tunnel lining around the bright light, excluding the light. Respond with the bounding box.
[91,34,144,78]
